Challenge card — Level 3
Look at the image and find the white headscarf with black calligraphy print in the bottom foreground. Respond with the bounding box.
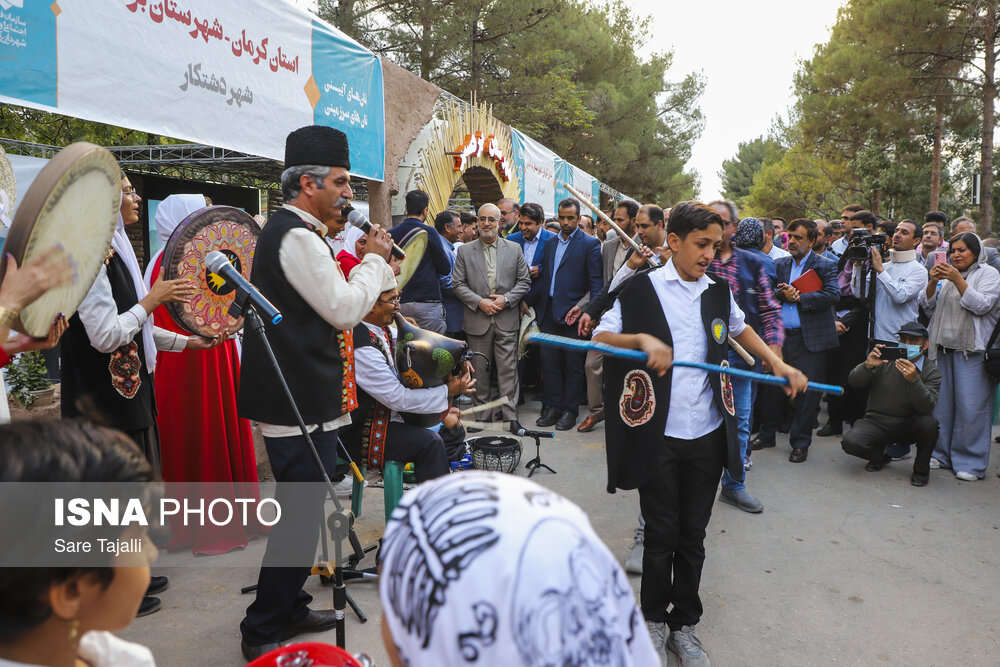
[379,471,659,667]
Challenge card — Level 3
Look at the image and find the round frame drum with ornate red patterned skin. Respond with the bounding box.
[161,206,260,338]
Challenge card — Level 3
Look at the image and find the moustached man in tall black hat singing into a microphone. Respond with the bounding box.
[239,125,393,660]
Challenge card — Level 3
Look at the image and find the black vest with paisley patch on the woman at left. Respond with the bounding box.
[59,254,156,431]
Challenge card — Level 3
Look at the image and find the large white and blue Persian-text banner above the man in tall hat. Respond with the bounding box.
[0,0,385,180]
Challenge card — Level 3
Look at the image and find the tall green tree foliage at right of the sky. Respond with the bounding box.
[750,0,978,224]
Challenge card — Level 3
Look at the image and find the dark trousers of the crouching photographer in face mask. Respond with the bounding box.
[841,415,938,475]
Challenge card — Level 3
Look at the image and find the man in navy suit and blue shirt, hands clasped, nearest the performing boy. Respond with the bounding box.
[527,198,603,431]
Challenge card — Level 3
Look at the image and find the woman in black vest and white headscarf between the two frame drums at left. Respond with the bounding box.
[60,173,218,616]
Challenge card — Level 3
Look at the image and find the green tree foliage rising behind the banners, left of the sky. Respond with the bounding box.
[319,0,704,203]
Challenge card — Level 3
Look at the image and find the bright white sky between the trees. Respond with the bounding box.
[291,0,844,201]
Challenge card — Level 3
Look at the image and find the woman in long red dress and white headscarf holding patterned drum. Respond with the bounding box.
[147,195,258,555]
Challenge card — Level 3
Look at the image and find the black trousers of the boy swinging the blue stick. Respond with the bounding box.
[639,426,726,630]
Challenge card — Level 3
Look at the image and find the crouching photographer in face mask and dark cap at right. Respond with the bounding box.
[841,321,941,486]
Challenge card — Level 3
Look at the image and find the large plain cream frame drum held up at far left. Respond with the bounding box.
[0,142,122,338]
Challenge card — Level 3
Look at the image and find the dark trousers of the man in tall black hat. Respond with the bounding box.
[240,430,337,646]
